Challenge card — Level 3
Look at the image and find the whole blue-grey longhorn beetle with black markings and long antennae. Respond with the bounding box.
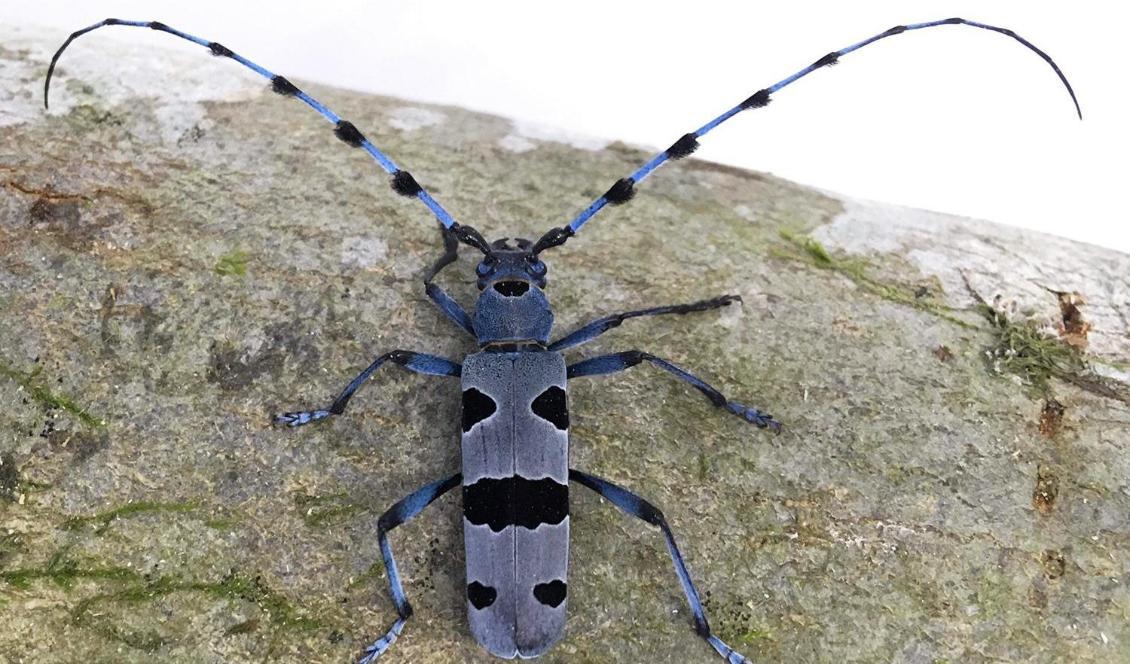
[43,18,1083,664]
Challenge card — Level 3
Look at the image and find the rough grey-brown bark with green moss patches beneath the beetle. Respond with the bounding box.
[0,27,1130,663]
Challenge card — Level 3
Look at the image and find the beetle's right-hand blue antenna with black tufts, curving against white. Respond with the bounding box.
[533,18,1083,253]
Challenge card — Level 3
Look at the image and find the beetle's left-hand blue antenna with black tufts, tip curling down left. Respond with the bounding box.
[43,18,470,241]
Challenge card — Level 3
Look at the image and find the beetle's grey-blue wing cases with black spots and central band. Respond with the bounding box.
[461,352,570,658]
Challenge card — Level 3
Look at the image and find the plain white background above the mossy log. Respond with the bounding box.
[0,0,1130,251]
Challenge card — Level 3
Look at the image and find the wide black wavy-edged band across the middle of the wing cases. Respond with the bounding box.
[463,475,568,533]
